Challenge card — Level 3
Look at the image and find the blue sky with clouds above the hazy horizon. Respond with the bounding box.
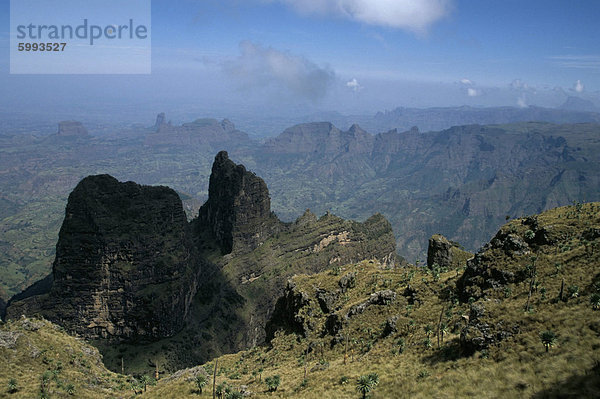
[0,0,600,122]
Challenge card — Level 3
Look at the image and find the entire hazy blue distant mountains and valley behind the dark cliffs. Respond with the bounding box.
[0,111,600,299]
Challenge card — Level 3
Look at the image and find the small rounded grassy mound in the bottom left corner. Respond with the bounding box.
[0,318,126,398]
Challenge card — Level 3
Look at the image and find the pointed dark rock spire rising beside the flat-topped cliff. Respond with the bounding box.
[198,151,281,254]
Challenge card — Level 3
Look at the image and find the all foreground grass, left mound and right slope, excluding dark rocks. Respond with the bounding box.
[0,203,600,399]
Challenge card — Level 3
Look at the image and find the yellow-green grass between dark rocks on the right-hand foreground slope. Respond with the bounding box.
[147,203,600,398]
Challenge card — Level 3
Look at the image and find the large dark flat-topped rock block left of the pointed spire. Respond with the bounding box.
[7,175,198,338]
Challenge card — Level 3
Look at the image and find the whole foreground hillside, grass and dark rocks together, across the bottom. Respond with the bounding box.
[0,203,600,398]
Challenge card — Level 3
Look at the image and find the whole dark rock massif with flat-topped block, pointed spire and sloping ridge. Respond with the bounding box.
[7,151,398,369]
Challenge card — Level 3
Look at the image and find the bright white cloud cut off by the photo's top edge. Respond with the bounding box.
[270,0,452,32]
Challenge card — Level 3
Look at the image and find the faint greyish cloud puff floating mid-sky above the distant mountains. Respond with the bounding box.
[223,41,335,101]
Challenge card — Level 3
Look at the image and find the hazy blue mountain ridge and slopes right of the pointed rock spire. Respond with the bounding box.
[252,123,600,261]
